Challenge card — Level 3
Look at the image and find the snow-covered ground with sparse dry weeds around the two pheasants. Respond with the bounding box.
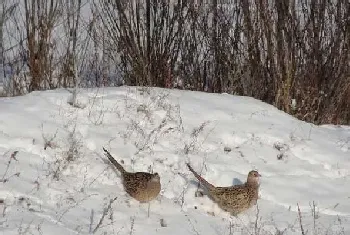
[0,87,350,235]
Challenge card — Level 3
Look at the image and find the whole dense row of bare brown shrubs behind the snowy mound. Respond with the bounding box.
[1,0,350,124]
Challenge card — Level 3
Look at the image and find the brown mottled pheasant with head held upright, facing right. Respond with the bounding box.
[187,164,261,216]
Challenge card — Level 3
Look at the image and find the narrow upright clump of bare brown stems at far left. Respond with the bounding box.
[24,0,63,92]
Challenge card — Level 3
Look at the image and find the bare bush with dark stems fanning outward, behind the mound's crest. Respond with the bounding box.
[99,0,186,87]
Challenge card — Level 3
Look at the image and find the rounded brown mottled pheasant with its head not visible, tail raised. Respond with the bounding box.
[103,148,161,202]
